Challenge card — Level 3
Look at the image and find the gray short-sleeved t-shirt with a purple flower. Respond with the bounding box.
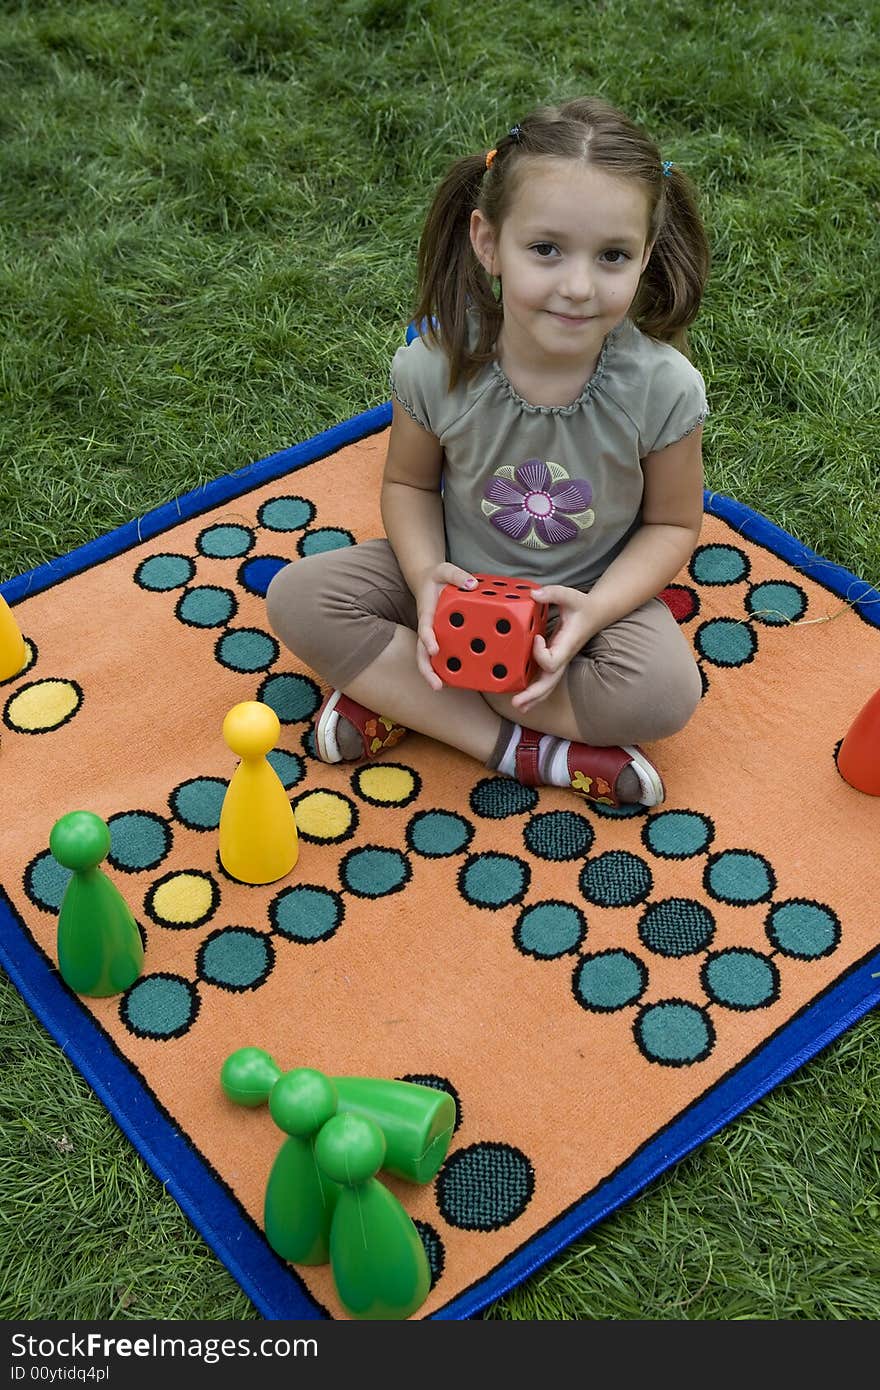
[391,318,708,589]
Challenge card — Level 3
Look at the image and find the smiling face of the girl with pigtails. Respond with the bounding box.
[471,156,651,370]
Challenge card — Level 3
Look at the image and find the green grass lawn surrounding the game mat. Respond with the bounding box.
[0,0,880,1321]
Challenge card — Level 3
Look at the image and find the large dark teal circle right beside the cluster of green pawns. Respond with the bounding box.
[435,1141,535,1230]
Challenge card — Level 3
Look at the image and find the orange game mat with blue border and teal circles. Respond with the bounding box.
[0,406,880,1319]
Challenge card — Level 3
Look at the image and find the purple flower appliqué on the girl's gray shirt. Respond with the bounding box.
[482,459,595,549]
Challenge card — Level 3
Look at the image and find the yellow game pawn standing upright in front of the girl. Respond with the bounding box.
[220,701,299,884]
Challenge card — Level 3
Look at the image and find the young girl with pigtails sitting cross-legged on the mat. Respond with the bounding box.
[267,99,709,806]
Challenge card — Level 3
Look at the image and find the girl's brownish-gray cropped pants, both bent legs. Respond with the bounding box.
[266,541,702,745]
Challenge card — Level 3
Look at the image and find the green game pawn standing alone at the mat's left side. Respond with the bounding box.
[49,810,143,998]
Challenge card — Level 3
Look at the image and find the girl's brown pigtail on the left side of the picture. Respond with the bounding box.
[414,154,502,391]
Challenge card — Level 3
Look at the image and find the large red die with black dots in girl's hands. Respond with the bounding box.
[431,574,548,694]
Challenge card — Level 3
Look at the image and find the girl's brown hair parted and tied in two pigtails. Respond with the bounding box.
[414,97,709,389]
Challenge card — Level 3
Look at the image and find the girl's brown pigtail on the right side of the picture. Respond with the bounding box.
[631,164,709,353]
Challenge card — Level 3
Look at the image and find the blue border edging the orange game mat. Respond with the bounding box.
[0,402,880,1321]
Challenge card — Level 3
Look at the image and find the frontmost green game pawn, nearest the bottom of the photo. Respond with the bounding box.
[314,1113,431,1319]
